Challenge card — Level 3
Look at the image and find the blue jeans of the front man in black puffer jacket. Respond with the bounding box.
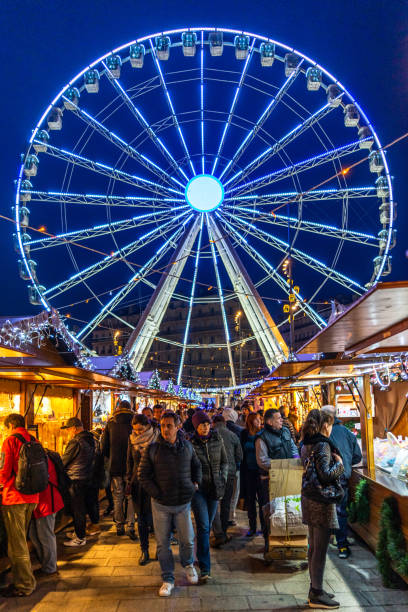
[152,499,194,583]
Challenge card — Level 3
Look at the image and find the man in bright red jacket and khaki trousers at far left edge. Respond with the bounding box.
[0,413,38,597]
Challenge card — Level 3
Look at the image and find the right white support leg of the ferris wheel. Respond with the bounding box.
[209,218,288,369]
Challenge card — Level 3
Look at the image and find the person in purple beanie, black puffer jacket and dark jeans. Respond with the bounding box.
[191,410,228,582]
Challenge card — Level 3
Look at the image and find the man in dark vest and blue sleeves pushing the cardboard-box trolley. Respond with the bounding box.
[255,408,299,548]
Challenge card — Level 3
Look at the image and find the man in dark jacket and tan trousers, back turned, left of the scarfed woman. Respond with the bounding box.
[101,400,136,539]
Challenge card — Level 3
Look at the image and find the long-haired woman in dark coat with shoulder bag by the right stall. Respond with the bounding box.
[301,409,344,609]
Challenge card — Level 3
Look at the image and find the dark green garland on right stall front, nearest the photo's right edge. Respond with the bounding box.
[376,497,408,588]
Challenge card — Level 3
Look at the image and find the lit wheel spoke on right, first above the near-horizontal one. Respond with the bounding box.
[227,140,368,194]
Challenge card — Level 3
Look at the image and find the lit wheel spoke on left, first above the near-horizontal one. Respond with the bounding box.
[34,140,183,196]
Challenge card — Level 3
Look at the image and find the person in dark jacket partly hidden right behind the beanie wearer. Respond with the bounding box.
[213,414,242,548]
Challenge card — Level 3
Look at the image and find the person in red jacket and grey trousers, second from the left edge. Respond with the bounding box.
[29,457,64,578]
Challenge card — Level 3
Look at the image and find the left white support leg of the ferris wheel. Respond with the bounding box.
[126,218,200,372]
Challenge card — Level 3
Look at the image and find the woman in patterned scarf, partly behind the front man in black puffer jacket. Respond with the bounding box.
[126,414,160,565]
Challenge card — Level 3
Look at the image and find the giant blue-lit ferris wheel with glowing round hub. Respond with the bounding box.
[14,27,396,384]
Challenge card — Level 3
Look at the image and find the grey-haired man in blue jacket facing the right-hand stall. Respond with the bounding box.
[322,405,362,559]
